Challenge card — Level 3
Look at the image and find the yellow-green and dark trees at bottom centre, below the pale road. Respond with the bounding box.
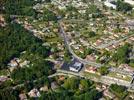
[39,77,102,100]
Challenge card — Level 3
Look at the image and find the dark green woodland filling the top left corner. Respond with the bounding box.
[1,0,36,15]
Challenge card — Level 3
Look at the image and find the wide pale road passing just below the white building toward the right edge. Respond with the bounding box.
[48,70,131,87]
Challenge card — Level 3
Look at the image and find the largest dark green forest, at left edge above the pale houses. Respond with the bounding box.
[0,23,50,69]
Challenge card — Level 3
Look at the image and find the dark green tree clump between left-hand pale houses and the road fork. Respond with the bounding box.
[11,59,53,83]
